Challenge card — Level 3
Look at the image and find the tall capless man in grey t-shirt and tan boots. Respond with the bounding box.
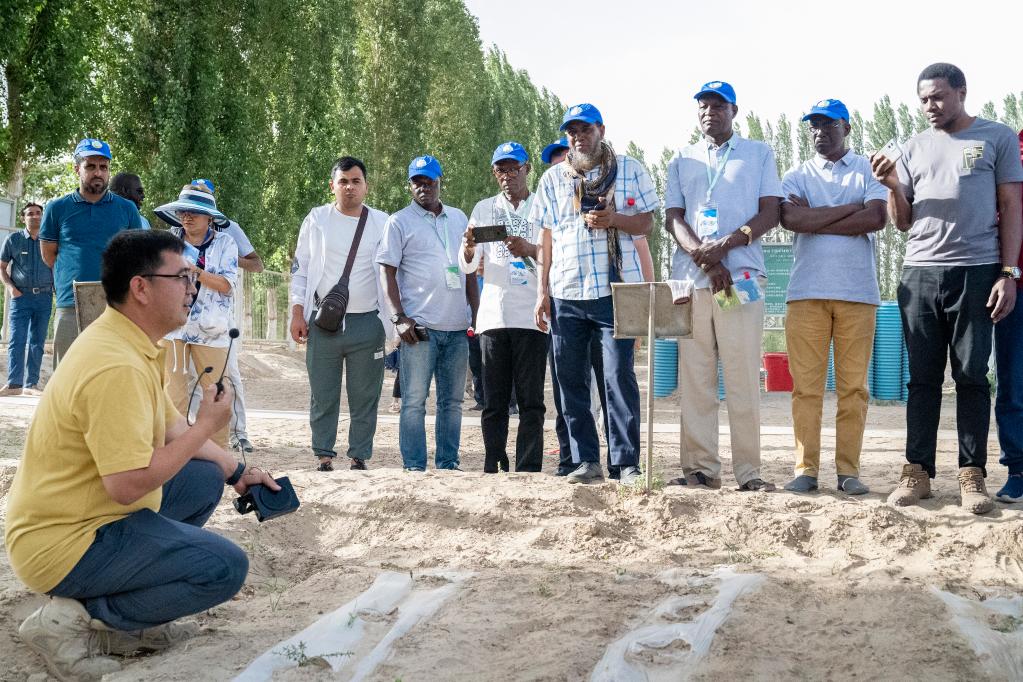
[871,63,1023,513]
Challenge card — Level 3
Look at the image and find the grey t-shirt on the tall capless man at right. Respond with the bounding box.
[898,118,1023,266]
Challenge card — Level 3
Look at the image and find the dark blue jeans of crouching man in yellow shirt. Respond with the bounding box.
[50,459,249,630]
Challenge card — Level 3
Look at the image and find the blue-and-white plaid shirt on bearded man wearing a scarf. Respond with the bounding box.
[529,154,659,301]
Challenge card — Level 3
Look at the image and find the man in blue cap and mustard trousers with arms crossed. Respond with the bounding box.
[782,99,888,495]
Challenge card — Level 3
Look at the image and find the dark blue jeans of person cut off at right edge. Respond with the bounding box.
[994,289,1023,473]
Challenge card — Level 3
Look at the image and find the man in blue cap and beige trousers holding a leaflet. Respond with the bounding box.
[665,81,782,491]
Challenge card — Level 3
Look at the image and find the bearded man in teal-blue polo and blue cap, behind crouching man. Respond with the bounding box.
[39,138,143,369]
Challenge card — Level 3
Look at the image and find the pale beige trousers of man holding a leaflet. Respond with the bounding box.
[678,282,764,486]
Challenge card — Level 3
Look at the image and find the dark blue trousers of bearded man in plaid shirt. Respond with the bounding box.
[550,297,639,466]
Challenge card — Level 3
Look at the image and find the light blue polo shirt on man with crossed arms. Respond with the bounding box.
[782,151,888,306]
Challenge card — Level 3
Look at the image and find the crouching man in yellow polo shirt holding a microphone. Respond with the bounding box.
[5,231,279,680]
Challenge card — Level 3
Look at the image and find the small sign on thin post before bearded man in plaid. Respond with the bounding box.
[611,282,693,490]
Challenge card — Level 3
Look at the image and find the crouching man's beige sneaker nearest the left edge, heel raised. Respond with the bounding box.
[17,597,121,681]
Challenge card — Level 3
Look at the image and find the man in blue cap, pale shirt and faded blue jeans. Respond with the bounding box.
[376,156,479,471]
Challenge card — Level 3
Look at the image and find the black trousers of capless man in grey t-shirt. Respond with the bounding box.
[898,265,999,479]
